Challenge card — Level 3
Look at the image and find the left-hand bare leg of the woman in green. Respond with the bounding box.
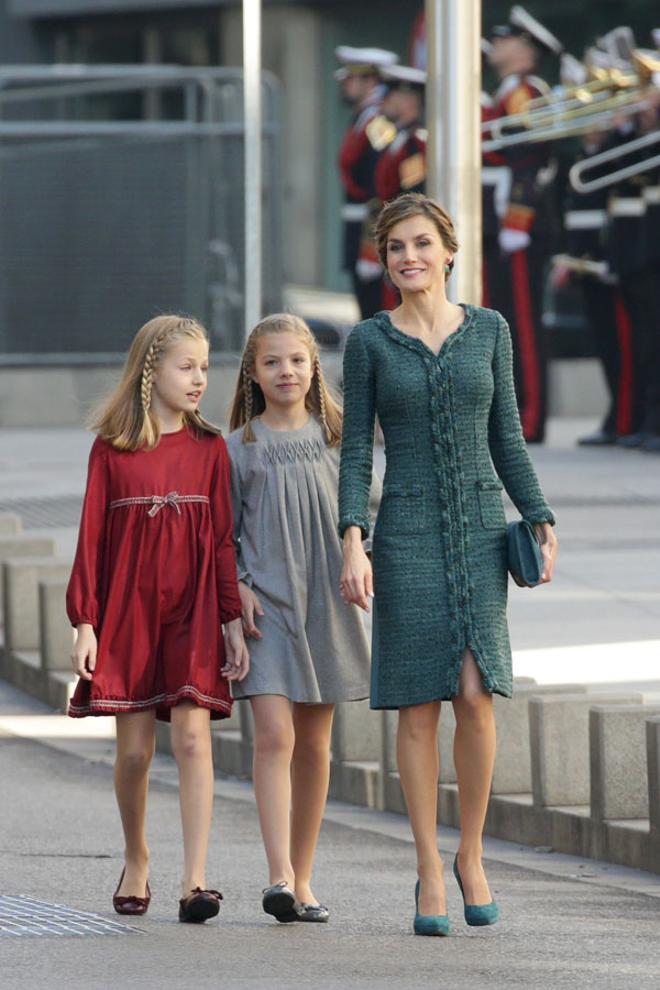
[397,701,447,914]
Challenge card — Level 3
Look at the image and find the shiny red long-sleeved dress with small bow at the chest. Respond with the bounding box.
[67,429,241,721]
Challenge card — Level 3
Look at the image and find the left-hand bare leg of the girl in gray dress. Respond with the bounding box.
[250,694,295,889]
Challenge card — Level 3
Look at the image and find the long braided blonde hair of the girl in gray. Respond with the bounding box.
[230,313,342,447]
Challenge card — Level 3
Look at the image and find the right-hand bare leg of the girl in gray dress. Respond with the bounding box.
[291,704,334,904]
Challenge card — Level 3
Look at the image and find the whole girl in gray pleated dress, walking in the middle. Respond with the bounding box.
[227,314,369,922]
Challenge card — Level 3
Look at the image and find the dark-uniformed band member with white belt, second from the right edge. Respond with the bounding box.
[553,130,634,447]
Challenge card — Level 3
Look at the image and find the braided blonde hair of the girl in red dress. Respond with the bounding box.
[89,315,220,450]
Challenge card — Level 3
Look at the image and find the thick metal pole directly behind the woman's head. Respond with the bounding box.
[426,0,481,304]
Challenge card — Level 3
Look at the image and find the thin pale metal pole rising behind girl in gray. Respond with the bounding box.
[243,0,262,336]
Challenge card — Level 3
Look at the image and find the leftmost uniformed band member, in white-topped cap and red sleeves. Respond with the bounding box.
[335,45,398,319]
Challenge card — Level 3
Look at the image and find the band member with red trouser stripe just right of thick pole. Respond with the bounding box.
[483,6,562,443]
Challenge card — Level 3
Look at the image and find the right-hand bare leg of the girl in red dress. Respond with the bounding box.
[172,701,213,897]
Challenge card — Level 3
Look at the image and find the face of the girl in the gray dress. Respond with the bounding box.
[252,330,312,409]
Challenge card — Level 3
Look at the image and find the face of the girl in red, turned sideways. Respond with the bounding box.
[151,337,209,418]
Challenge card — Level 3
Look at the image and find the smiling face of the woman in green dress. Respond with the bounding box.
[387,216,452,292]
